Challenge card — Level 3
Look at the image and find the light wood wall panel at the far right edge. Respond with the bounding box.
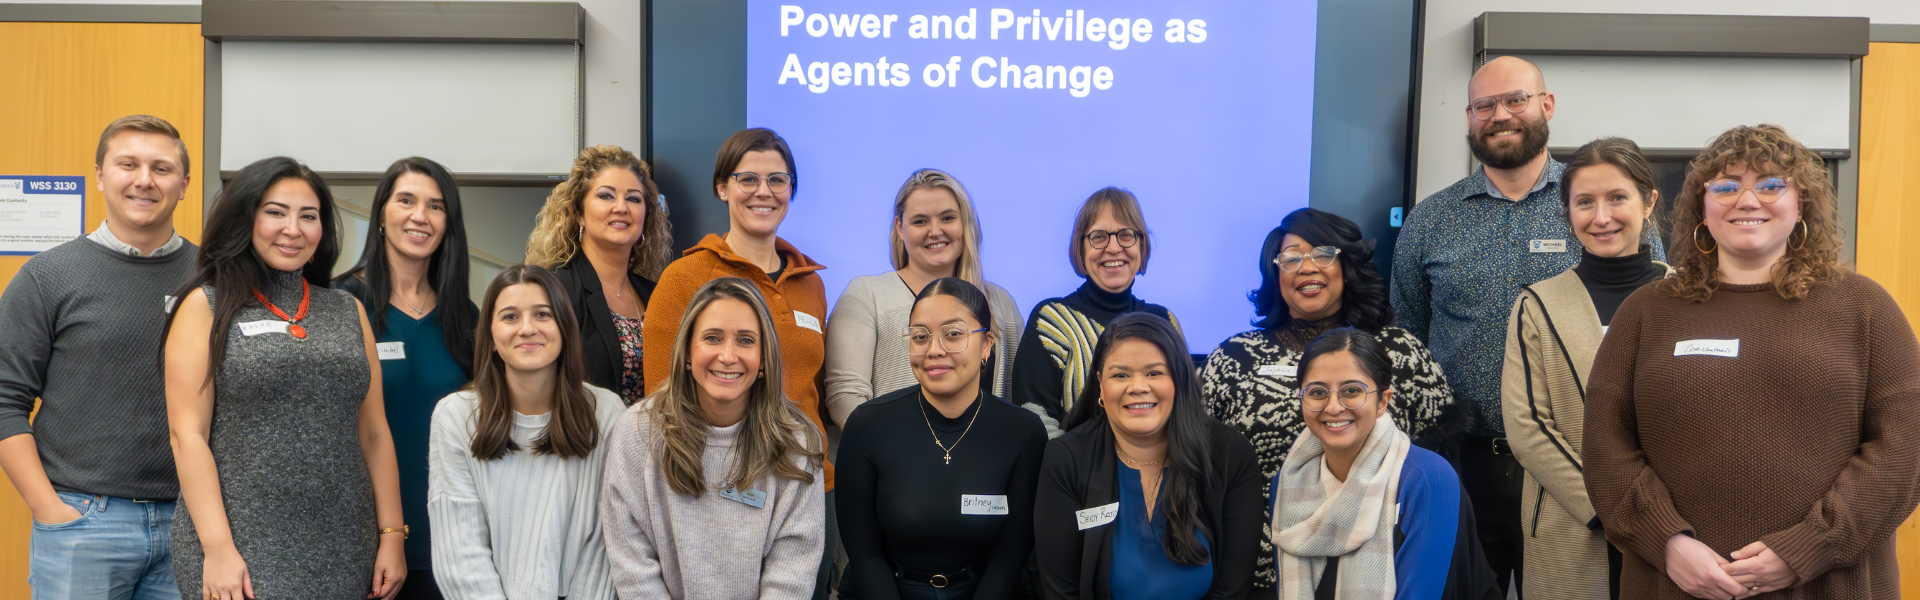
[1855,44,1920,600]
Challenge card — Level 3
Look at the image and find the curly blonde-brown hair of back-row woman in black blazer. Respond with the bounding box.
[526,146,674,279]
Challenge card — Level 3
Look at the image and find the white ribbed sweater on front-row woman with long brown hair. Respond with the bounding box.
[426,385,626,600]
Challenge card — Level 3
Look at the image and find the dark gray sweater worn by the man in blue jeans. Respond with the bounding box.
[0,238,200,500]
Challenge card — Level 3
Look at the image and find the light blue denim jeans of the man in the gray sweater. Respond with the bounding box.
[27,492,180,600]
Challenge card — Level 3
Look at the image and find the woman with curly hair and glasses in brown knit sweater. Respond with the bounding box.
[1580,125,1920,600]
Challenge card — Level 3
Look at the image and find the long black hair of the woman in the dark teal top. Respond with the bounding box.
[334,156,480,377]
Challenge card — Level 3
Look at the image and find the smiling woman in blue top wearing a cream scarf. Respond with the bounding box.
[1271,327,1500,600]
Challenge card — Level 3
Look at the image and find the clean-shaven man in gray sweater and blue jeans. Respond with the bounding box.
[0,115,198,600]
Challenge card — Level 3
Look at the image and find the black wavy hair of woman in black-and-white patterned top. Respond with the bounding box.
[1246,208,1394,331]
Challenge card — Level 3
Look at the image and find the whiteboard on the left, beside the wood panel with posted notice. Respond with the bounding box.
[221,42,580,173]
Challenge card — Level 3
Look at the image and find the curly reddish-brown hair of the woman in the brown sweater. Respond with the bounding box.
[1661,125,1845,302]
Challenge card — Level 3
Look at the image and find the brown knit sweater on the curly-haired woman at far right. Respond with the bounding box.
[1580,273,1920,600]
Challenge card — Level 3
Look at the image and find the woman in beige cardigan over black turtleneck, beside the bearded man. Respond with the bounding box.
[1501,138,1668,600]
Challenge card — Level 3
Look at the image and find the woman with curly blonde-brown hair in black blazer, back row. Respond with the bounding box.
[526,146,674,404]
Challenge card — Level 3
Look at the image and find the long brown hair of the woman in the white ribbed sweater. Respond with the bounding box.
[467,263,599,460]
